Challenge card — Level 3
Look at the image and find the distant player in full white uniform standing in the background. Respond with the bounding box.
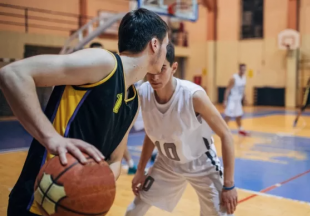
[224,64,249,136]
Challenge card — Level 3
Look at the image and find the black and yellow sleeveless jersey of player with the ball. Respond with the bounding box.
[10,53,138,215]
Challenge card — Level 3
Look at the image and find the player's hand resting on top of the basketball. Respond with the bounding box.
[44,135,104,165]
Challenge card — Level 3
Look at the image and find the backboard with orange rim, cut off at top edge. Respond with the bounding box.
[138,0,198,22]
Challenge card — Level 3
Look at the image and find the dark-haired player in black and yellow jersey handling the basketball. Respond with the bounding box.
[0,9,168,216]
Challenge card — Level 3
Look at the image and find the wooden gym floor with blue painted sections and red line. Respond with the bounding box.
[0,107,310,216]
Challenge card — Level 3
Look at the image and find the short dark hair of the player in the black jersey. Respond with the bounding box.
[118,8,169,53]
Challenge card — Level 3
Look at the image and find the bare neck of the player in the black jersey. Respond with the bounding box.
[120,53,148,89]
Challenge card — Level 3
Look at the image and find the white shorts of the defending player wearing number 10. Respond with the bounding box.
[140,151,226,216]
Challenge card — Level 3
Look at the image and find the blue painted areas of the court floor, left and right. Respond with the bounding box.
[0,110,310,202]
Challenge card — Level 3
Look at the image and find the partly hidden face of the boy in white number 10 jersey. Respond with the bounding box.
[146,59,178,91]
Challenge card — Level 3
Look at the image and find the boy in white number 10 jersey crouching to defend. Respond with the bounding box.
[126,44,237,216]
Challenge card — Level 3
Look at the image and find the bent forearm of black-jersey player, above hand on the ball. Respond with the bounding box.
[0,67,57,145]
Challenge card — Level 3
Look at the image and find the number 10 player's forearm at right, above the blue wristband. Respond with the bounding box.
[221,133,235,187]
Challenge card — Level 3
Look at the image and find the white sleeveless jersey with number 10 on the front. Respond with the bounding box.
[139,78,216,164]
